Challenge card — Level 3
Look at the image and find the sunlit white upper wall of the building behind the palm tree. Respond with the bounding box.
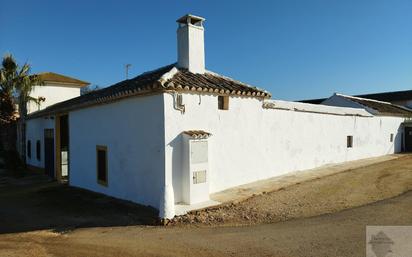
[27,83,80,113]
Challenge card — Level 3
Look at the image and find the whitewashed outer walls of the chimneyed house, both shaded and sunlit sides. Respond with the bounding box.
[27,93,404,218]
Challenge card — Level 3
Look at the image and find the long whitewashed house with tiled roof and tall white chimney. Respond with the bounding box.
[27,15,412,218]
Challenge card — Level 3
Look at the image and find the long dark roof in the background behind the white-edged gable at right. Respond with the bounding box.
[299,90,412,108]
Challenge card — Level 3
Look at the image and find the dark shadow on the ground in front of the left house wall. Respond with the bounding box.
[0,171,158,233]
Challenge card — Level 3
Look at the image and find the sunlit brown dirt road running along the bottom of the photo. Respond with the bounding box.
[0,192,412,257]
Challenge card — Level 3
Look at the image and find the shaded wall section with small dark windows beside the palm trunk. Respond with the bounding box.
[26,118,54,168]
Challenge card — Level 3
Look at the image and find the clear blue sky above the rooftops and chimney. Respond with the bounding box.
[0,0,412,100]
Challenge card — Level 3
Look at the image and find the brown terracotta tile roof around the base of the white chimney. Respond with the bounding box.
[29,64,270,118]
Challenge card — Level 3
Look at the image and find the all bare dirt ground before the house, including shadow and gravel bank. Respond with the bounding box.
[0,155,412,257]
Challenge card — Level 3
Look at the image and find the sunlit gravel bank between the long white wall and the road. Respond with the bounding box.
[168,155,412,226]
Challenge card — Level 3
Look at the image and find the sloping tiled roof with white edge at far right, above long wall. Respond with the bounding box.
[337,94,412,117]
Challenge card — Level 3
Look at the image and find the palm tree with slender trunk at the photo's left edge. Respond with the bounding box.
[0,54,43,162]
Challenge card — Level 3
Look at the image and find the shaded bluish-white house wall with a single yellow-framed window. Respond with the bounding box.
[69,95,164,208]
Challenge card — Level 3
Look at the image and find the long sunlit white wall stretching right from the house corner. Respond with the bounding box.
[165,94,403,202]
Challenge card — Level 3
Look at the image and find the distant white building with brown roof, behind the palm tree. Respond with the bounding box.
[27,72,90,113]
